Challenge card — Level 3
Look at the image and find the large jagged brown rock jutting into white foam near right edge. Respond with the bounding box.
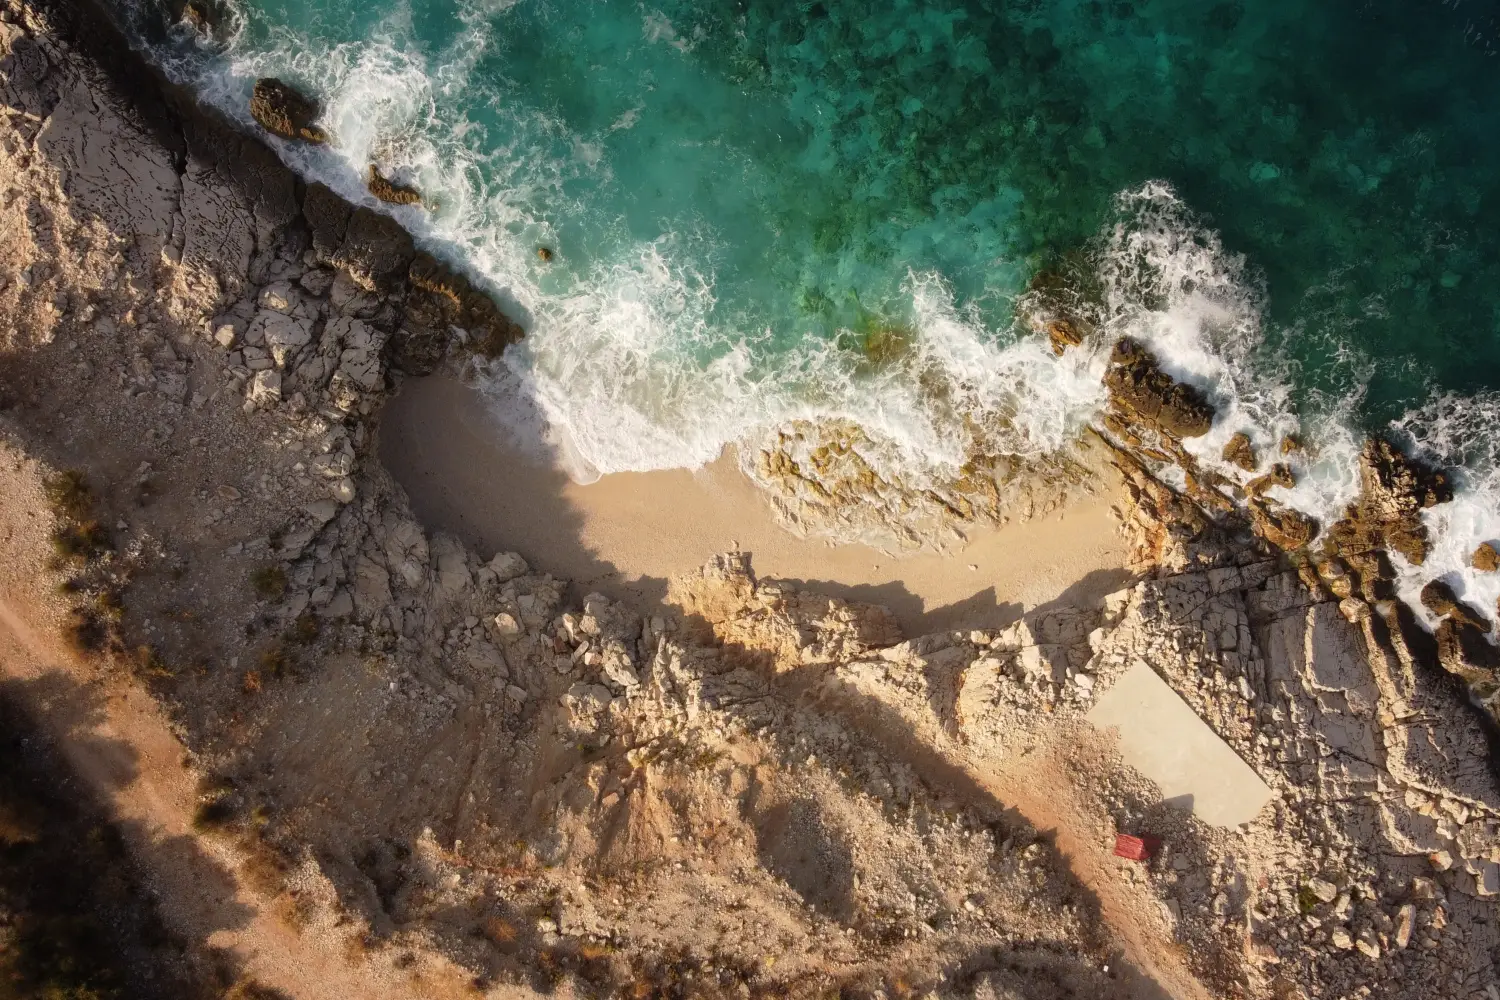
[1329,438,1454,565]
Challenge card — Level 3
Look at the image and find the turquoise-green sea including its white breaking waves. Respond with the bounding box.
[122,0,1500,604]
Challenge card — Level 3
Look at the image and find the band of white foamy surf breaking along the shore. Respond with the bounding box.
[111,4,1500,641]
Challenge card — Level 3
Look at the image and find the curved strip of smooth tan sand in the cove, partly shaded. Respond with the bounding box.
[380,376,1130,634]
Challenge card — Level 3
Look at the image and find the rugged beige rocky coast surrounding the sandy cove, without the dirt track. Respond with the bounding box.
[0,0,1500,1000]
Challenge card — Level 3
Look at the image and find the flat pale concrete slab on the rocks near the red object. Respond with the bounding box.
[1088,663,1272,829]
